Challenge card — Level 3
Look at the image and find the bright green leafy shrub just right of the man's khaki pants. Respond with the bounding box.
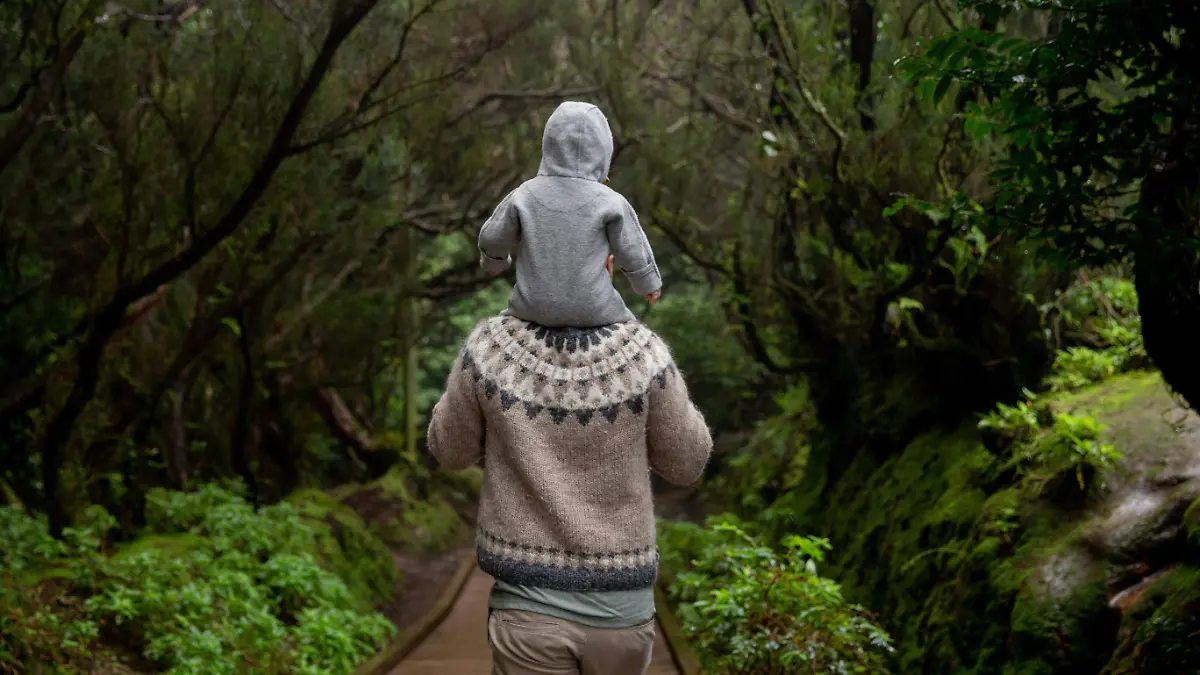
[660,518,892,675]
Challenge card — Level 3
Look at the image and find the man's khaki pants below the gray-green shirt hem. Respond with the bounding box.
[487,609,654,675]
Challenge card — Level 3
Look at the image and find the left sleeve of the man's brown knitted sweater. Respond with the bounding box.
[428,350,484,471]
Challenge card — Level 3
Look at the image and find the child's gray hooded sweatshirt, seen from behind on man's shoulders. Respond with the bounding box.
[479,101,662,328]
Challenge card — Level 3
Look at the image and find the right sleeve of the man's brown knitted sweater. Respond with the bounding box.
[646,365,713,485]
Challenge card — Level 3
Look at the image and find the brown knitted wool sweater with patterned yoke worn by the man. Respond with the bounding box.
[428,316,713,591]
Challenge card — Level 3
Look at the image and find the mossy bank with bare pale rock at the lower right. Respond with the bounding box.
[820,371,1200,675]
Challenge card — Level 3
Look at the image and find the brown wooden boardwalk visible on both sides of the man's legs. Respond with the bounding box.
[391,568,679,675]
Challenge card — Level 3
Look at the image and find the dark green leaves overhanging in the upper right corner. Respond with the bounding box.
[902,0,1196,264]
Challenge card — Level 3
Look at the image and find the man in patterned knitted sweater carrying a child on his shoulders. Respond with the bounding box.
[428,316,713,675]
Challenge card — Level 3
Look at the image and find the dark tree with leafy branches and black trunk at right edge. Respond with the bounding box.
[906,0,1200,410]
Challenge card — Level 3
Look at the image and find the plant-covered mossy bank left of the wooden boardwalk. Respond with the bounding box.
[0,461,478,675]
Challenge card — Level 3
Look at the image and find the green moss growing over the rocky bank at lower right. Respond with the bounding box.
[816,372,1200,675]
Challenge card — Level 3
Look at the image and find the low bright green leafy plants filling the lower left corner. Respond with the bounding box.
[0,485,395,675]
